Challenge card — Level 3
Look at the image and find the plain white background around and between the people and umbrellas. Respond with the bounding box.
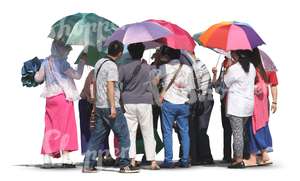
[0,0,300,180]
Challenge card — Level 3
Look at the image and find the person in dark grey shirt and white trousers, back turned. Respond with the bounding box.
[119,43,159,170]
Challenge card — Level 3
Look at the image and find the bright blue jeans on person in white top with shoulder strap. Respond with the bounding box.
[161,101,190,164]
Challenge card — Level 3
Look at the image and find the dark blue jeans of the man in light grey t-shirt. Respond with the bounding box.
[83,108,130,168]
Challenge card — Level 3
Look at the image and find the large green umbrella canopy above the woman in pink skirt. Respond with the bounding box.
[49,13,118,48]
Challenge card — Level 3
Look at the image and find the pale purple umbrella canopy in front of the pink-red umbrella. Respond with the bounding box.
[105,22,172,46]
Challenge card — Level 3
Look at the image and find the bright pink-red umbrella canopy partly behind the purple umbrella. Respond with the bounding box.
[146,19,196,52]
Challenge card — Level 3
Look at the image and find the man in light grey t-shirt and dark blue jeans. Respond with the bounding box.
[82,41,138,173]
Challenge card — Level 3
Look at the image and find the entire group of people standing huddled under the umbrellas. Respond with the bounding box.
[35,40,278,173]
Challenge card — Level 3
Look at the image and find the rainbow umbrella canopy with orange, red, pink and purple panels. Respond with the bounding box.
[196,21,265,51]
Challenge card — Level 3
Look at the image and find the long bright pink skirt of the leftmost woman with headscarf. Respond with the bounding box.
[41,94,78,158]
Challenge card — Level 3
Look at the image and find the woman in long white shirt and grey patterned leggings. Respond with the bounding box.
[224,50,256,168]
